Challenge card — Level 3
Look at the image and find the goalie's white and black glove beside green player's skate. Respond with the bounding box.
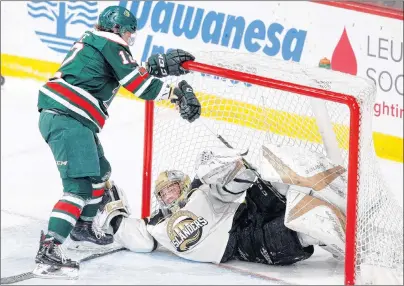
[93,182,130,234]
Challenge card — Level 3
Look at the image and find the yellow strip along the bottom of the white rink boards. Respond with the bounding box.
[1,54,404,162]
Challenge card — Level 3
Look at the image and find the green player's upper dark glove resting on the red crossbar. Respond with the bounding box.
[147,49,195,78]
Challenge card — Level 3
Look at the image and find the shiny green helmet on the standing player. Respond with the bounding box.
[97,6,137,46]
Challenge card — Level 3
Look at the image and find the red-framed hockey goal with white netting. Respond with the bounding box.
[142,52,403,285]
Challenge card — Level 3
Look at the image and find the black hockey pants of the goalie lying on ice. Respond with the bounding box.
[222,181,314,265]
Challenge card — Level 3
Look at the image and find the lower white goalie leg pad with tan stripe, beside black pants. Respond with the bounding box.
[285,186,346,259]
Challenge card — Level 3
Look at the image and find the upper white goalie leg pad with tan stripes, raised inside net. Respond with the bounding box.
[259,144,347,213]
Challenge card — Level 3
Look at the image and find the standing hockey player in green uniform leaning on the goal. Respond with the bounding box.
[35,6,201,278]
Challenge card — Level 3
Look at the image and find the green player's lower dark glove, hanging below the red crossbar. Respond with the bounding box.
[171,80,201,122]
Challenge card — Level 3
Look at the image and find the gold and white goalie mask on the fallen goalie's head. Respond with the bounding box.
[154,170,191,212]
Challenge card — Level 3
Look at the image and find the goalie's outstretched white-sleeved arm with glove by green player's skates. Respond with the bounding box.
[93,183,157,252]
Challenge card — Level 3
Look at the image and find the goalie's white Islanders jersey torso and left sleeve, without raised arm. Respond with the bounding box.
[114,185,243,263]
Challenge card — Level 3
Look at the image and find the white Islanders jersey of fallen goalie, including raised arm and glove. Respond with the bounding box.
[114,147,255,263]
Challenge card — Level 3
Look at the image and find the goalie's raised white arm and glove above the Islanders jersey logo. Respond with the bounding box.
[196,148,256,202]
